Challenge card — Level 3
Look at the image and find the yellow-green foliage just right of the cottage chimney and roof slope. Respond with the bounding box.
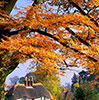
[34,74,63,100]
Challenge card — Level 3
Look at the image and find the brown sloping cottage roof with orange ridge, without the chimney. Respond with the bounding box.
[6,83,52,99]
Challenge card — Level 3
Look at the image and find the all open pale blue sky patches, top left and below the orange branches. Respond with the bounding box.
[5,0,82,90]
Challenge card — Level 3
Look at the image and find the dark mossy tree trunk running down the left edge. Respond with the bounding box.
[0,0,17,100]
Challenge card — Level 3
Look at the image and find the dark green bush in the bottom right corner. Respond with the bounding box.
[73,83,98,100]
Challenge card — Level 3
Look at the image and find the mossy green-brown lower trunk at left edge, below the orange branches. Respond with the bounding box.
[0,52,18,100]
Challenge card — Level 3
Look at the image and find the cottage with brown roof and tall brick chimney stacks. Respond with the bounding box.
[6,77,52,100]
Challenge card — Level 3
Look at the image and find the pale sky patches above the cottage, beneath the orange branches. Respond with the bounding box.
[5,59,82,89]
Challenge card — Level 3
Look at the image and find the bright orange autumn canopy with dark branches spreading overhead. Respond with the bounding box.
[0,0,99,99]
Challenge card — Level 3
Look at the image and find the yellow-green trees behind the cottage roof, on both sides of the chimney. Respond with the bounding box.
[19,71,63,100]
